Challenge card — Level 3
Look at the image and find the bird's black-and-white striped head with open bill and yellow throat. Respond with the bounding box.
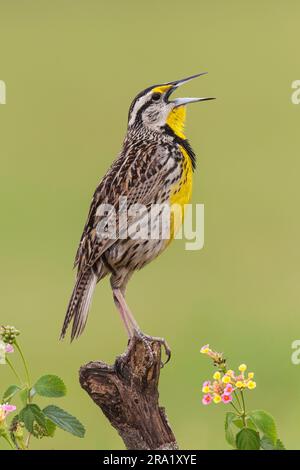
[128,73,213,138]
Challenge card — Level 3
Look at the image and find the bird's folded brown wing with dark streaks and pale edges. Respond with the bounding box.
[75,144,173,273]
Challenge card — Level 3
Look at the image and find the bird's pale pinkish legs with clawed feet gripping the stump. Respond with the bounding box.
[113,289,171,365]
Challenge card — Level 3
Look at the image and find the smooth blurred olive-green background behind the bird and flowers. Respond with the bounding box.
[0,0,300,449]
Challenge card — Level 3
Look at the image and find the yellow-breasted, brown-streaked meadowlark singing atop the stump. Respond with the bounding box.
[60,72,214,360]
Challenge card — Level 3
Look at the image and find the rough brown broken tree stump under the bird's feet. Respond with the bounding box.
[79,338,178,450]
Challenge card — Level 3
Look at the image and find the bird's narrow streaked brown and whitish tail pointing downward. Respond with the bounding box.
[60,271,97,341]
